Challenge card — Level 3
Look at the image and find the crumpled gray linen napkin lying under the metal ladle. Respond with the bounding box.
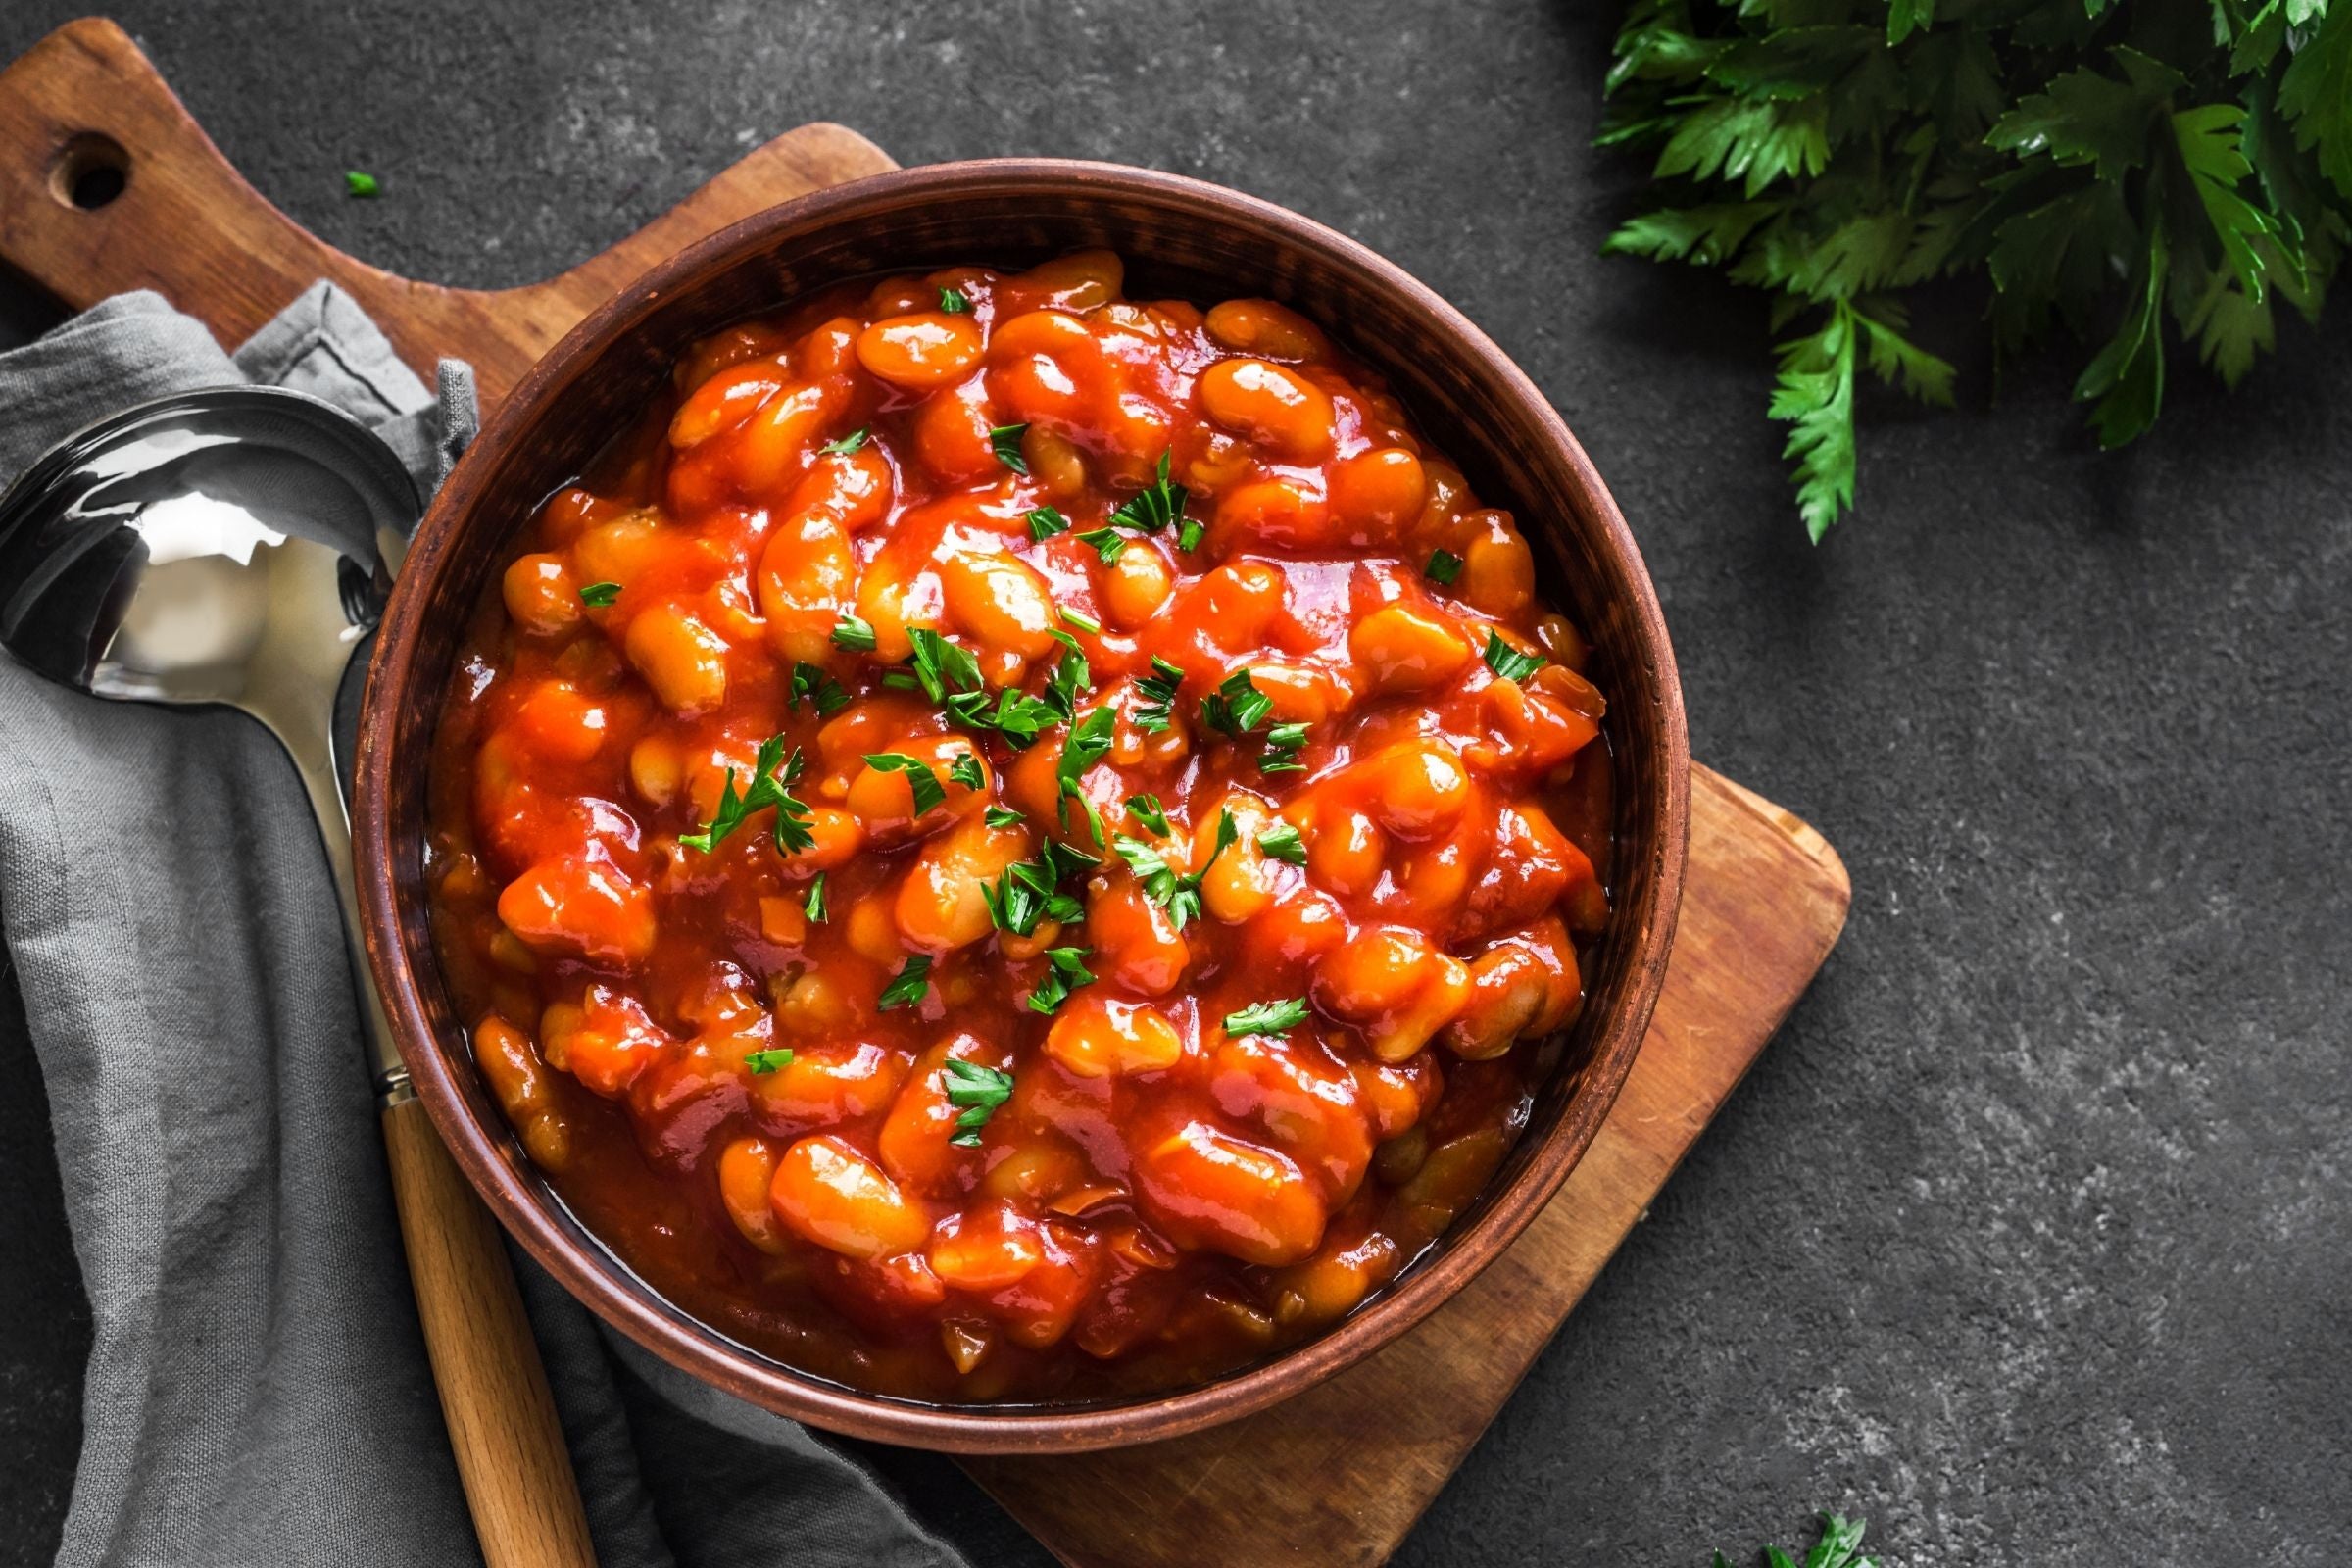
[0,284,959,1568]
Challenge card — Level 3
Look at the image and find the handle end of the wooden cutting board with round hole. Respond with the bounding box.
[0,17,896,402]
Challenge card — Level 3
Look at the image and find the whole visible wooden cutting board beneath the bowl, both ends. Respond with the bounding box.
[0,22,1848,1568]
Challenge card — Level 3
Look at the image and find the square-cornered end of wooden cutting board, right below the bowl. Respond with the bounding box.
[962,766,1848,1568]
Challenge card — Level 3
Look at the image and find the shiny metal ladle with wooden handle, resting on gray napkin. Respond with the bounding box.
[0,388,595,1568]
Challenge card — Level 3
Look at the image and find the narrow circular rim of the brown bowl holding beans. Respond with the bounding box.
[353,158,1689,1452]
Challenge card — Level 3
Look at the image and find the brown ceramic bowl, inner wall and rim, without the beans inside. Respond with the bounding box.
[358,160,1689,1452]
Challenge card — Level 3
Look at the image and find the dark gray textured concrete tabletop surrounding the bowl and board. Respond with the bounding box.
[0,0,2352,1568]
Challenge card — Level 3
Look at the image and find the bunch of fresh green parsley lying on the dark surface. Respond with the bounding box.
[1599,0,2352,540]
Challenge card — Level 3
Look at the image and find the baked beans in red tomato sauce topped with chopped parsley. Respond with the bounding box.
[428,252,1609,1401]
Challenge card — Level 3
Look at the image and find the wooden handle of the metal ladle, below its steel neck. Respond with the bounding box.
[383,1101,595,1568]
